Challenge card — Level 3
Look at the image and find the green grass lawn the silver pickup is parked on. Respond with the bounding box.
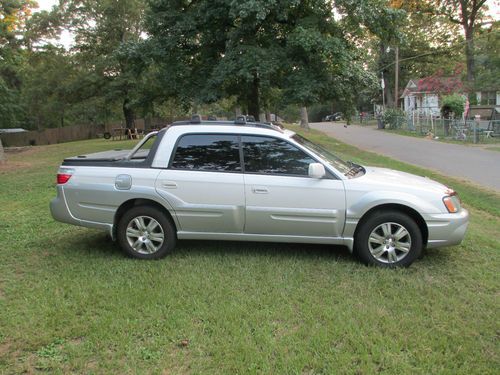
[0,131,500,374]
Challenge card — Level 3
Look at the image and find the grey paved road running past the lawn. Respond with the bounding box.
[310,122,500,192]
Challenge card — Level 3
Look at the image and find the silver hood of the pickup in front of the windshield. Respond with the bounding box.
[358,167,448,195]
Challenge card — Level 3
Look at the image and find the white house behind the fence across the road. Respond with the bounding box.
[401,76,500,116]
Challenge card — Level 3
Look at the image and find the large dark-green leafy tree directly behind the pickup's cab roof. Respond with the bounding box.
[146,0,397,118]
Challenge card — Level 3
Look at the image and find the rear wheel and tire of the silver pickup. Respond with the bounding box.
[117,206,177,259]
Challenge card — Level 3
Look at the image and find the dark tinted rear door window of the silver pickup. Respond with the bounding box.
[171,134,241,172]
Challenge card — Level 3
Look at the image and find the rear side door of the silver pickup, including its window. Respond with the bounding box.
[156,133,245,233]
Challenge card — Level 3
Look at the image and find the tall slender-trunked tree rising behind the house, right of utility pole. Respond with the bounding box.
[437,0,486,84]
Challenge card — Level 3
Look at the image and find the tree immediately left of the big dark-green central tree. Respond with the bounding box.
[60,0,146,128]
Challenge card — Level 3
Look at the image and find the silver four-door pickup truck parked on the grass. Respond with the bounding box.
[50,118,468,267]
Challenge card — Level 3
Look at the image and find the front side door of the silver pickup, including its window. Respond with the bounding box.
[241,136,345,237]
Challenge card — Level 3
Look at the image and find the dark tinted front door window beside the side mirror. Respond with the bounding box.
[241,136,316,176]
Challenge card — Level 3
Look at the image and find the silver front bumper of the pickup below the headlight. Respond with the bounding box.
[424,208,469,249]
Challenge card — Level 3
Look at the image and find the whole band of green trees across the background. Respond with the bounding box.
[0,0,500,129]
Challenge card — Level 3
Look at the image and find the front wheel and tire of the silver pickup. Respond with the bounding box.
[354,211,423,268]
